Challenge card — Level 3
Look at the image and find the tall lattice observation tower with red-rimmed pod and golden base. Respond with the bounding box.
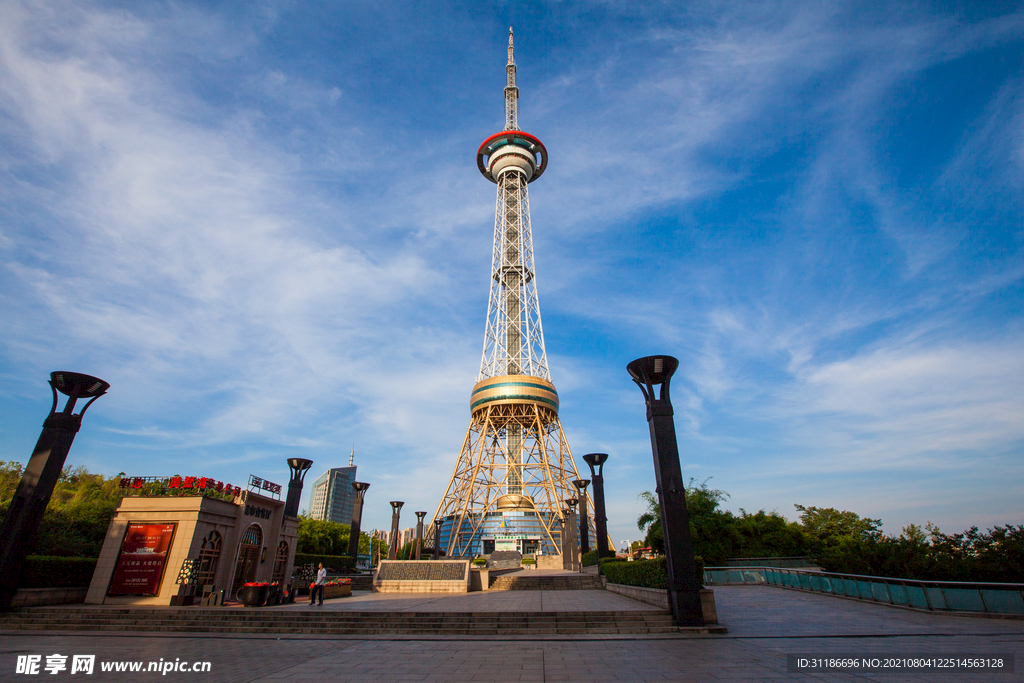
[434,29,594,556]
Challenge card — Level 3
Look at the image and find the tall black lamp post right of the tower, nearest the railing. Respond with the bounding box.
[626,355,705,626]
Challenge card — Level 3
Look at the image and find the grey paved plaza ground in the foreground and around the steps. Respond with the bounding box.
[0,586,1024,683]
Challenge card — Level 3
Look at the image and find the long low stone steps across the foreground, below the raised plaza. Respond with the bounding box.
[0,607,688,637]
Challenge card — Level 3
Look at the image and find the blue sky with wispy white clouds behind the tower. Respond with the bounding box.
[0,0,1024,541]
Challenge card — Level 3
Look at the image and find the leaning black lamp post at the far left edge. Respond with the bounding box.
[0,372,111,610]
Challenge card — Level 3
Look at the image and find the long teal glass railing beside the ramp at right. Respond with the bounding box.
[703,566,1024,614]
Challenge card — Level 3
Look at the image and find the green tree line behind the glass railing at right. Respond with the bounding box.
[637,479,1024,584]
